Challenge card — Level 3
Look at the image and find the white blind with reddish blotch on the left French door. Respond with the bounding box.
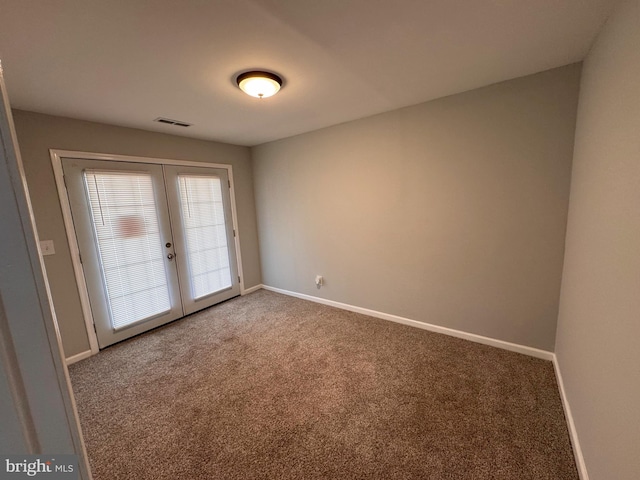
[84,170,171,330]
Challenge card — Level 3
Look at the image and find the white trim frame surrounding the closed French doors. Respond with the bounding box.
[49,149,246,355]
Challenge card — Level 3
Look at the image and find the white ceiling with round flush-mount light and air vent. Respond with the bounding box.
[0,0,615,145]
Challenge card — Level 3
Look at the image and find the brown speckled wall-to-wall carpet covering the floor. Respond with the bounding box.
[70,290,578,480]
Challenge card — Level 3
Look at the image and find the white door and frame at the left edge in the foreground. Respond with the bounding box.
[0,64,91,480]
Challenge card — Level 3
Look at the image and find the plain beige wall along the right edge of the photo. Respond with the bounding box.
[556,0,640,480]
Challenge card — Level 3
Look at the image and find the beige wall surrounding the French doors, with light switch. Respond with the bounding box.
[13,110,261,357]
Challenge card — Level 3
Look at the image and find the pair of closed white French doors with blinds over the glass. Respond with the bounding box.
[62,158,240,348]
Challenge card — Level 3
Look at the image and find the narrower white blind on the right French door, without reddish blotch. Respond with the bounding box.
[178,175,232,299]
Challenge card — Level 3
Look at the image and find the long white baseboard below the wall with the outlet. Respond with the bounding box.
[262,285,554,361]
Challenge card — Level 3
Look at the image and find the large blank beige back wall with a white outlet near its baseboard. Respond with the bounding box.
[252,64,580,350]
